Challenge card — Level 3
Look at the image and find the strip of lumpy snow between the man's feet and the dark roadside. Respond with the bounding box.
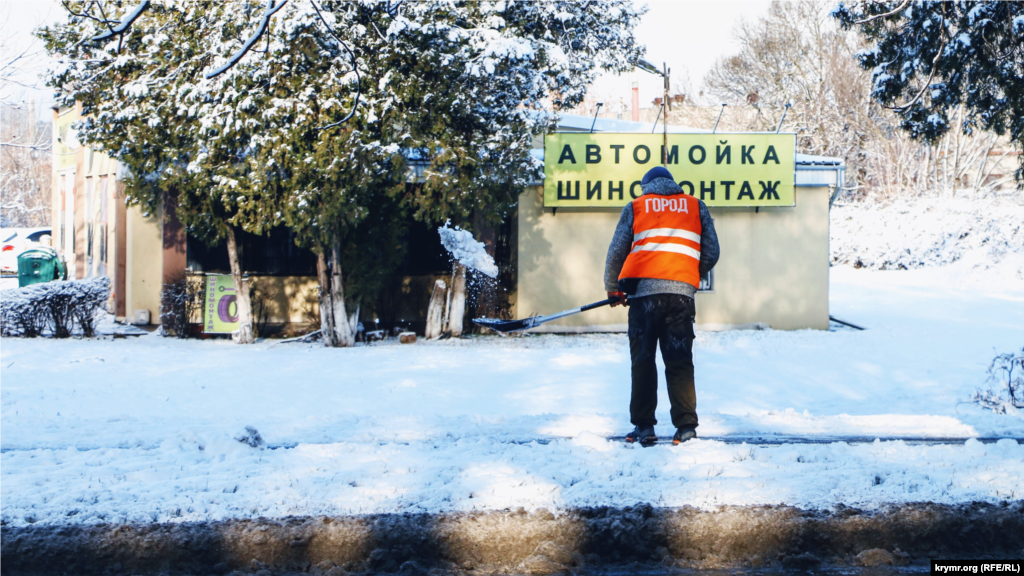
[0,430,1024,526]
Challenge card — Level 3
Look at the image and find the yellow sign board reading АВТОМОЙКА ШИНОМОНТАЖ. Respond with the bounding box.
[544,132,797,208]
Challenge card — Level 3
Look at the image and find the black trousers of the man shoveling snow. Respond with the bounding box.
[629,294,697,428]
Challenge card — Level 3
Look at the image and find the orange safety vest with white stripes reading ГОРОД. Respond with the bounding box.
[618,194,700,288]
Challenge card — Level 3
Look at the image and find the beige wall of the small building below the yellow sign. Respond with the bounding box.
[513,187,828,331]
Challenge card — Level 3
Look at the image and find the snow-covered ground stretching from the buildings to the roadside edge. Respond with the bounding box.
[0,260,1024,525]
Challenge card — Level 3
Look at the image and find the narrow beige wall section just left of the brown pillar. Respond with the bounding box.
[125,206,164,324]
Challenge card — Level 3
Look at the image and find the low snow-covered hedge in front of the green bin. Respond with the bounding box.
[0,277,111,338]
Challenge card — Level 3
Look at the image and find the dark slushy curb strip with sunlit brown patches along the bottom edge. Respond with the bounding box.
[0,502,1024,576]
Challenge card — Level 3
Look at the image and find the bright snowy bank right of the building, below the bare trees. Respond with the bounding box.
[830,193,1024,270]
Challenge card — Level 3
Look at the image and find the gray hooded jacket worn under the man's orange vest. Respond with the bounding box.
[604,178,720,298]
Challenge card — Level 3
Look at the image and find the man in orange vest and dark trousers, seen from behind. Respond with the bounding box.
[604,166,719,445]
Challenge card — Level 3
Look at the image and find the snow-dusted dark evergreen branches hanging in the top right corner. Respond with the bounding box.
[833,0,1024,178]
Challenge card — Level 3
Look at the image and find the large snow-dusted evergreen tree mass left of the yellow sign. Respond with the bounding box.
[41,0,639,344]
